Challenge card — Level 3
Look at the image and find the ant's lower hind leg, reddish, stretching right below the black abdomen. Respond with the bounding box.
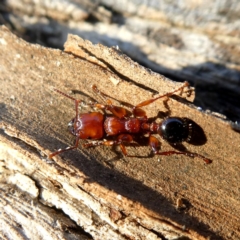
[149,136,212,164]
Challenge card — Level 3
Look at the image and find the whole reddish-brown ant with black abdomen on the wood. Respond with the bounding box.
[49,82,212,164]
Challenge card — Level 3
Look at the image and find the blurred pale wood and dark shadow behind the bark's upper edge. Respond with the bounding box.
[0,0,240,124]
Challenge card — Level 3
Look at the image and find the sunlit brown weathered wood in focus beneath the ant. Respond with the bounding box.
[0,27,240,239]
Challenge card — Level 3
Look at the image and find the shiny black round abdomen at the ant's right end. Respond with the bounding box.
[159,117,189,143]
